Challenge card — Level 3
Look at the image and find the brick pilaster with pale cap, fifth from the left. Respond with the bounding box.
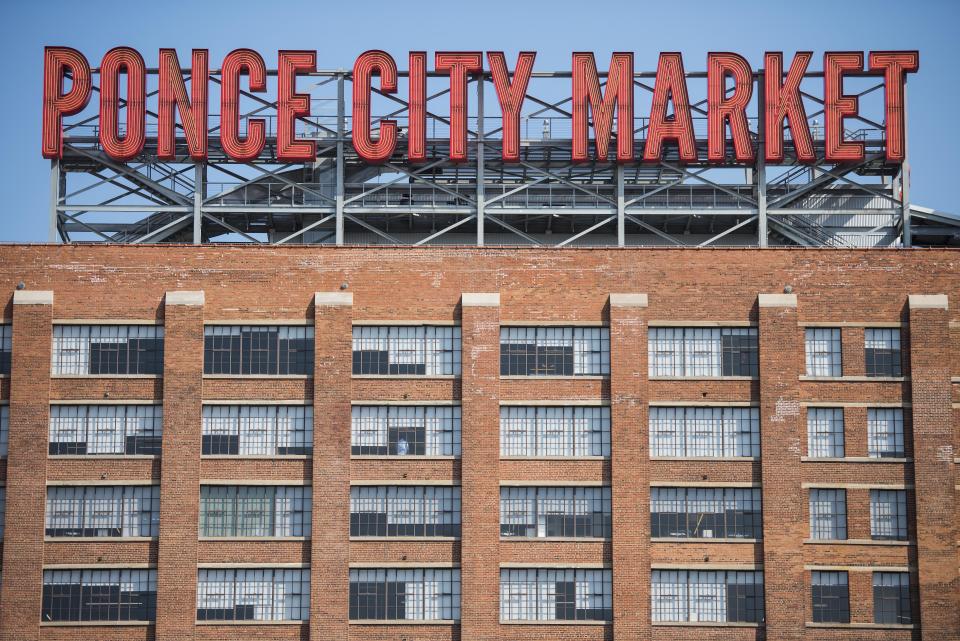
[610,294,651,639]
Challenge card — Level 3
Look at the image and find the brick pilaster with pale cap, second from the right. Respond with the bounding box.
[758,294,809,641]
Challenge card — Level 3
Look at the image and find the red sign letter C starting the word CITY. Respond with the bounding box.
[352,50,397,163]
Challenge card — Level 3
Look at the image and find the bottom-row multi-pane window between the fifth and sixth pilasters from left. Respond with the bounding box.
[650,570,764,623]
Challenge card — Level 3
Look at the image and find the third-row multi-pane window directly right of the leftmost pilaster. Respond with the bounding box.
[45,485,160,537]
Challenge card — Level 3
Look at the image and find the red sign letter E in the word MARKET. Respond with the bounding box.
[823,51,863,162]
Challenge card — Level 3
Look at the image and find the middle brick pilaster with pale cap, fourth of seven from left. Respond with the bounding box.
[460,293,500,641]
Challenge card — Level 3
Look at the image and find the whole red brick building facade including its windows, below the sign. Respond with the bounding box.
[0,245,960,641]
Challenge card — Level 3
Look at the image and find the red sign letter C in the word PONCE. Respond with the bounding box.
[220,49,267,162]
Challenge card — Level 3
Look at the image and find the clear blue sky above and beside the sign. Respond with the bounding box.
[0,0,960,241]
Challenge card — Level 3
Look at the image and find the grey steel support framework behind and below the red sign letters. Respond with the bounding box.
[50,63,960,247]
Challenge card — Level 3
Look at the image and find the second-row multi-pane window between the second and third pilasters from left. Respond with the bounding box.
[201,405,313,456]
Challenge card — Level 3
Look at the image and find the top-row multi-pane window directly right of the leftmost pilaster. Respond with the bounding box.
[53,325,163,376]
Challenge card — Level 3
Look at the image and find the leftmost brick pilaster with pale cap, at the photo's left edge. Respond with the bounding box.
[0,291,53,641]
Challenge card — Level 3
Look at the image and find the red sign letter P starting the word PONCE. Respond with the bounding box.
[41,47,90,158]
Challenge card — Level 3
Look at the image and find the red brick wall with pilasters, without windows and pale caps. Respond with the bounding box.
[0,245,960,641]
